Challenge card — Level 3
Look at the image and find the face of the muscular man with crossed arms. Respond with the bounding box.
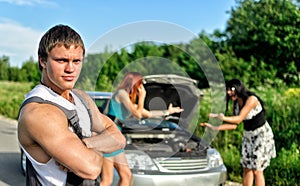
[41,45,83,93]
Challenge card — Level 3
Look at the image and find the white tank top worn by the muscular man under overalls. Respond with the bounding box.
[20,85,91,186]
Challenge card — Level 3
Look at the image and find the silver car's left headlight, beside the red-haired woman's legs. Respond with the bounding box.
[125,150,158,170]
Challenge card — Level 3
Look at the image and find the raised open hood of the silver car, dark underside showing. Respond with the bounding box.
[143,74,203,128]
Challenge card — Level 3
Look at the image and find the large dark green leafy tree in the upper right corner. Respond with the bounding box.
[226,0,300,85]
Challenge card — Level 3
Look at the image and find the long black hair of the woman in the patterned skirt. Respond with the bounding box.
[226,79,265,115]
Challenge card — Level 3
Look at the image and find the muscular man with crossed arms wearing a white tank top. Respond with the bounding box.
[18,25,125,185]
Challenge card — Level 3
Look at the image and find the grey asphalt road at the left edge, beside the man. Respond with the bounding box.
[0,117,26,186]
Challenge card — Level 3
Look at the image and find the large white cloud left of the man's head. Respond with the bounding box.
[0,18,43,66]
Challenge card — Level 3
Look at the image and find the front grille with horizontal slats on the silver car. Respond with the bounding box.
[155,158,208,173]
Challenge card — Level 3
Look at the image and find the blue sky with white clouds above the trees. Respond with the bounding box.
[0,0,236,67]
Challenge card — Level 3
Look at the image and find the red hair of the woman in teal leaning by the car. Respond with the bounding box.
[118,72,143,103]
